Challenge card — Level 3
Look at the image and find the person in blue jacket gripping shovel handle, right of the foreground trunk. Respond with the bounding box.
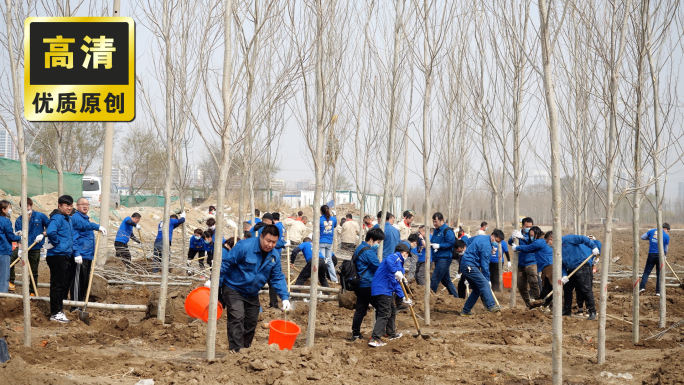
[561,234,599,320]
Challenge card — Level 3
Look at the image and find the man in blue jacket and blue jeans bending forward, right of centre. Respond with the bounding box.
[459,229,504,317]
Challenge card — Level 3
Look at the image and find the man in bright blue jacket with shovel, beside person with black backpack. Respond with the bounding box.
[368,242,412,348]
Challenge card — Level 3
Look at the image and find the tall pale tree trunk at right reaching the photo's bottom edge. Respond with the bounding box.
[540,0,563,385]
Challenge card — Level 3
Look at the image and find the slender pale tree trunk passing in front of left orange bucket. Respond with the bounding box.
[207,0,232,360]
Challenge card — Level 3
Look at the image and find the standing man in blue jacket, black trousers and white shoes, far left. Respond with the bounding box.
[46,195,76,323]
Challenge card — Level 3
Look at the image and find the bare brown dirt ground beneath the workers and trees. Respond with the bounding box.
[0,226,684,385]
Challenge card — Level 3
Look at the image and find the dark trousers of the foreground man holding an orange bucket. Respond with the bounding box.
[221,286,260,352]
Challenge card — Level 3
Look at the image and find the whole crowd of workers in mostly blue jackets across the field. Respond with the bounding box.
[0,195,670,351]
